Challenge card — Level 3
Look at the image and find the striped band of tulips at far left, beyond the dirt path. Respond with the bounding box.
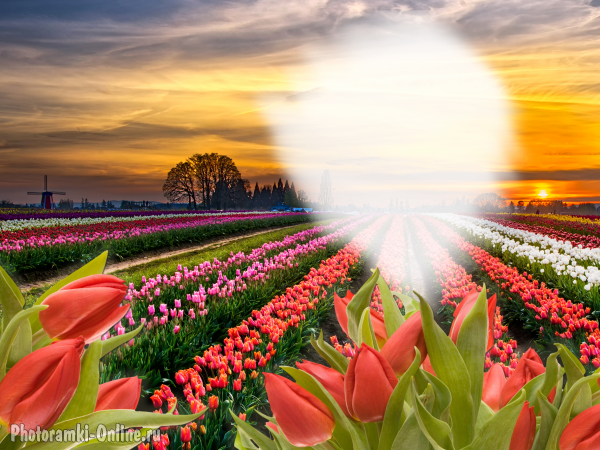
[0,211,339,274]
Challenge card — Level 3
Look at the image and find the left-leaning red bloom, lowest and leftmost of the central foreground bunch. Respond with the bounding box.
[264,373,335,447]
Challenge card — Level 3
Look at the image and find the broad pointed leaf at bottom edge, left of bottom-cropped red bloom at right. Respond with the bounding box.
[468,390,525,450]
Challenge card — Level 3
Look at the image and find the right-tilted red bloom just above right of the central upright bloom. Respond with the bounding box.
[381,311,427,376]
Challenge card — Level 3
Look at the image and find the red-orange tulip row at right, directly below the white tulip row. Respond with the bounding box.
[420,216,600,367]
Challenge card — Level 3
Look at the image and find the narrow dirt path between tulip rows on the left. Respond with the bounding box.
[17,224,301,292]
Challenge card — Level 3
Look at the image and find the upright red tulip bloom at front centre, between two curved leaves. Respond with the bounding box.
[344,344,398,423]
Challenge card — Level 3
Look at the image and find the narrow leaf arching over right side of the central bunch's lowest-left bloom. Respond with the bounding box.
[281,366,369,450]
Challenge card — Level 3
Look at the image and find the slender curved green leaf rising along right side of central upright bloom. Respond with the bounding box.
[379,347,421,450]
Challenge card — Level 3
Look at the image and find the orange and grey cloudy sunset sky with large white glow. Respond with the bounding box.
[0,0,600,206]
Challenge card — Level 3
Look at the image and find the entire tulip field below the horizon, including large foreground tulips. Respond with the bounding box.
[0,212,600,450]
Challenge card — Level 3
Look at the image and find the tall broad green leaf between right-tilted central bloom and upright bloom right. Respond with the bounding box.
[421,292,476,448]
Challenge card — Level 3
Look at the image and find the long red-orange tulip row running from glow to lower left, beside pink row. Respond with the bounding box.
[141,216,389,442]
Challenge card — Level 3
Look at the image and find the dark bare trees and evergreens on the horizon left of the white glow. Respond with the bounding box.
[163,153,334,210]
